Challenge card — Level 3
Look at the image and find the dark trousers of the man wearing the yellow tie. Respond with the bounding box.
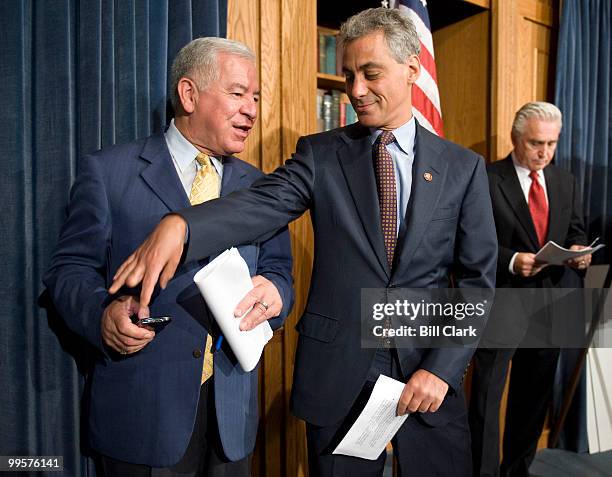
[100,377,251,477]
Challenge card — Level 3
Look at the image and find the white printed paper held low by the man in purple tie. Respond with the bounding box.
[333,374,408,460]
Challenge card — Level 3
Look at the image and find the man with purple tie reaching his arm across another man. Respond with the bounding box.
[112,8,497,477]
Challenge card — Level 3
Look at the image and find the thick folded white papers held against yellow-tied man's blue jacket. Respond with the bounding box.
[193,248,272,372]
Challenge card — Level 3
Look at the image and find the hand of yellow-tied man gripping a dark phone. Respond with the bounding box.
[101,296,155,354]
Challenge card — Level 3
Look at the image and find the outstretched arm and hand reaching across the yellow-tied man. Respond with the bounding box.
[109,138,314,306]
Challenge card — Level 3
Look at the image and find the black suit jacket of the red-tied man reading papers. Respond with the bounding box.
[484,156,587,347]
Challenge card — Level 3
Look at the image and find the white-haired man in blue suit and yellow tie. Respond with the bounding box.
[45,38,293,477]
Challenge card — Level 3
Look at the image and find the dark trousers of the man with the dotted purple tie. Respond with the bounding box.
[306,350,472,477]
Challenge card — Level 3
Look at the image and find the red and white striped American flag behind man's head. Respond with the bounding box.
[393,0,443,136]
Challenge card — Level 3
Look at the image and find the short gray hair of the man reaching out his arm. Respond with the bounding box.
[338,7,421,63]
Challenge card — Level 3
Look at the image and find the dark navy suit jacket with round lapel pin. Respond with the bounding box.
[181,124,497,425]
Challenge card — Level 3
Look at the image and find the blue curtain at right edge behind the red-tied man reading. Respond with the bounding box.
[555,0,612,452]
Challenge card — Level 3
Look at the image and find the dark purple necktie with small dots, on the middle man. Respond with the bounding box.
[374,131,397,267]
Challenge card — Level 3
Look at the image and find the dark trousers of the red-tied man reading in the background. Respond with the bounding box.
[470,348,559,477]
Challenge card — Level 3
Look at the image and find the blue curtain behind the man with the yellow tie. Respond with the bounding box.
[0,0,227,476]
